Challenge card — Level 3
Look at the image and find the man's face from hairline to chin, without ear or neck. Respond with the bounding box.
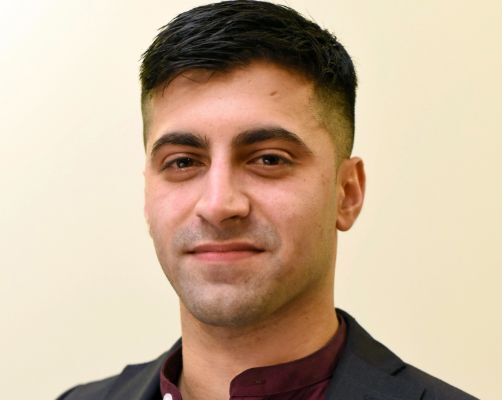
[145,62,356,326]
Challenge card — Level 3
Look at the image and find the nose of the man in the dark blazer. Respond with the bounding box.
[195,163,250,227]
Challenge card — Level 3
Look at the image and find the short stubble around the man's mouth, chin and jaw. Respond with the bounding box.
[151,219,322,328]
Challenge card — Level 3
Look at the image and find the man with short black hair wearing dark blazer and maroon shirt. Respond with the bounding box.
[60,0,472,400]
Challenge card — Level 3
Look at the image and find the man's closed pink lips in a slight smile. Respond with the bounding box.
[187,242,265,262]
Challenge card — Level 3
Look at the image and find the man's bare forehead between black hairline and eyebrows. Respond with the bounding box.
[143,62,326,151]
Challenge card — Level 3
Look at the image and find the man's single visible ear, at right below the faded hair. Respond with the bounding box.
[336,157,366,231]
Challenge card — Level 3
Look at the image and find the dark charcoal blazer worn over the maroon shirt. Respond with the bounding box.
[57,309,475,400]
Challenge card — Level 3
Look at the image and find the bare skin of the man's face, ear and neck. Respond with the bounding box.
[144,62,365,399]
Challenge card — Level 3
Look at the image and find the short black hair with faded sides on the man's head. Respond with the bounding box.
[140,0,357,156]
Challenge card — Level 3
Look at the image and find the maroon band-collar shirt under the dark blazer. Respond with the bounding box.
[160,318,347,400]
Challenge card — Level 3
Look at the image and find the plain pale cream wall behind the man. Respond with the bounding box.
[0,0,502,399]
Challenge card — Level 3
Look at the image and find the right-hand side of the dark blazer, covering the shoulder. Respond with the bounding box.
[334,310,475,400]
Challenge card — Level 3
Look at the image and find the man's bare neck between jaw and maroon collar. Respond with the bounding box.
[179,290,338,400]
